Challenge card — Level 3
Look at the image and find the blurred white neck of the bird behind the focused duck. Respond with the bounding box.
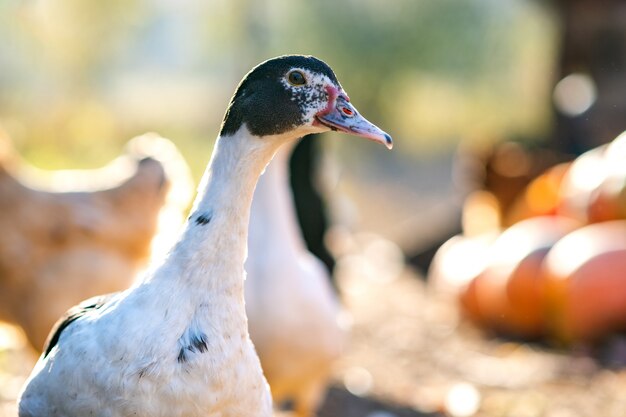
[249,142,306,255]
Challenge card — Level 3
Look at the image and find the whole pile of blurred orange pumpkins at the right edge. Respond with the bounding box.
[429,132,626,344]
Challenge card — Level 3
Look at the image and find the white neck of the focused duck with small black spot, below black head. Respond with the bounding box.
[155,126,284,292]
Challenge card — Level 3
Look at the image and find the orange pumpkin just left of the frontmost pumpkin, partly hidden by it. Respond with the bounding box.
[461,216,579,338]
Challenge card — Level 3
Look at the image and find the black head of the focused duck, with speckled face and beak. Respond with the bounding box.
[220,55,393,149]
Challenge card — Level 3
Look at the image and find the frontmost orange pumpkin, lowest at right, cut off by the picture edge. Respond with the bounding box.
[544,220,626,343]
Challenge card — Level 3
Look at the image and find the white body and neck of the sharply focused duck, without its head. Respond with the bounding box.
[20,128,272,417]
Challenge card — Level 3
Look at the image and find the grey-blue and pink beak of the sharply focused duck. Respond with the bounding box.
[316,93,393,149]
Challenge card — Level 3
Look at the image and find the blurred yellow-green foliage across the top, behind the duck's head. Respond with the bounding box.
[0,0,556,172]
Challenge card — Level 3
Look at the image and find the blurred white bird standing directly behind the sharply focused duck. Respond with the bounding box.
[244,143,345,417]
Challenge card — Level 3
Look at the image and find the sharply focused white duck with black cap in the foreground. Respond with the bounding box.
[18,55,392,417]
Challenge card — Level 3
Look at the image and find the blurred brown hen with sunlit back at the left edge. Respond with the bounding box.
[0,134,192,354]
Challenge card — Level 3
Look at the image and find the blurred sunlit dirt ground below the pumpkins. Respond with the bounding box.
[0,231,626,417]
